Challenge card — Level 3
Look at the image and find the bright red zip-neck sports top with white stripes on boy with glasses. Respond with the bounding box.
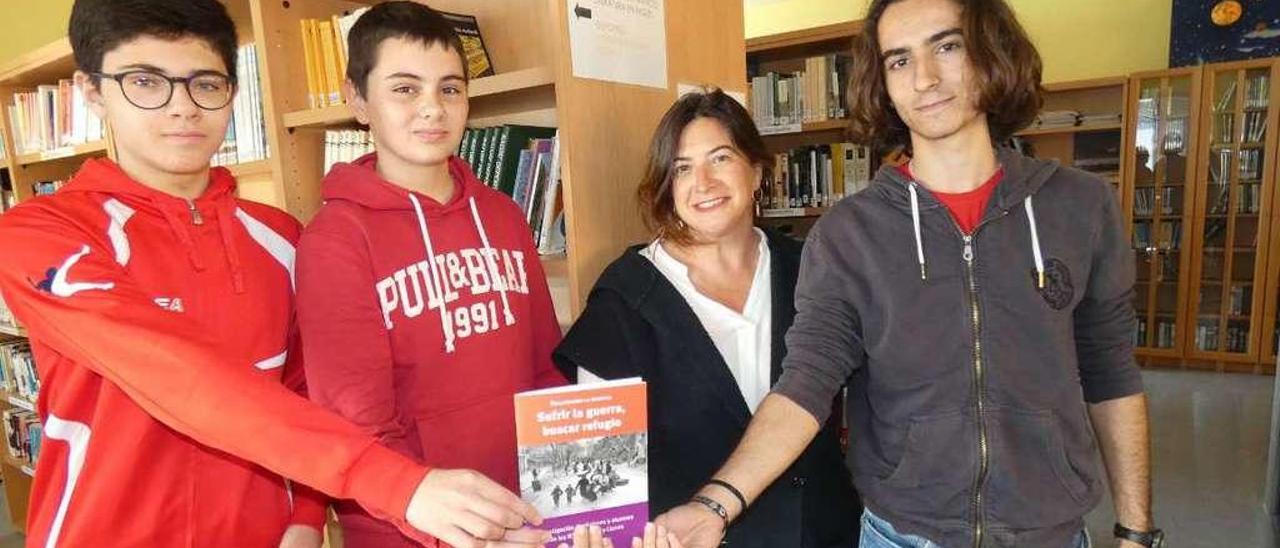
[0,160,425,548]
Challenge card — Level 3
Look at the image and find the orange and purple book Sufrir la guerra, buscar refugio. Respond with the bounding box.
[515,379,649,547]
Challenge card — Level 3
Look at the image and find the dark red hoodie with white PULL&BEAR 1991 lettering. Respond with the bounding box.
[298,154,564,548]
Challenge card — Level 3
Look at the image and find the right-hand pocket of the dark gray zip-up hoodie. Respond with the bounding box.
[986,408,1096,529]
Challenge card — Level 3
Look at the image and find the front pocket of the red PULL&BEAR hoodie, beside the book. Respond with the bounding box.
[416,394,520,494]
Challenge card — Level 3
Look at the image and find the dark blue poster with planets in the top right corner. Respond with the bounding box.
[1169,0,1280,67]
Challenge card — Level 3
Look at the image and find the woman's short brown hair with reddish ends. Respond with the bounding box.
[636,88,773,243]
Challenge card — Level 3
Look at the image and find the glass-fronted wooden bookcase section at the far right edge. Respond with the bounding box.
[1184,58,1280,373]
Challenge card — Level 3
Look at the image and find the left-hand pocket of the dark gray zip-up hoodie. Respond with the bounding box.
[868,411,978,522]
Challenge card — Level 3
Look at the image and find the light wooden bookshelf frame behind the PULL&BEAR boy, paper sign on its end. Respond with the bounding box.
[252,0,746,316]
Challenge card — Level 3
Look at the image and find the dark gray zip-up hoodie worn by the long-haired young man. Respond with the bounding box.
[773,149,1142,548]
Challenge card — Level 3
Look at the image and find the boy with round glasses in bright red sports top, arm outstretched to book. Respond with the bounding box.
[0,0,545,548]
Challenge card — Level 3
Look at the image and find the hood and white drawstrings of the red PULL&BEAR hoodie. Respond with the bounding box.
[323,152,515,353]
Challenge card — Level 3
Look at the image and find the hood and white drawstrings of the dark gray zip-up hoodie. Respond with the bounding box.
[870,147,1060,288]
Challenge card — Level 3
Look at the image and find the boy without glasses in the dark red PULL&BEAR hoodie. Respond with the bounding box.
[298,1,564,548]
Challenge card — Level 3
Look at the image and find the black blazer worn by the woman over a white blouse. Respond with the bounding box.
[554,232,861,548]
